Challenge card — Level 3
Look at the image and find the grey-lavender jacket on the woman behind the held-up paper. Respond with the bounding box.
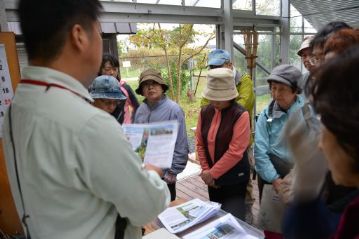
[134,96,189,175]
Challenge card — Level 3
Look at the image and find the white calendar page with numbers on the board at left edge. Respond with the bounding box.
[0,43,14,138]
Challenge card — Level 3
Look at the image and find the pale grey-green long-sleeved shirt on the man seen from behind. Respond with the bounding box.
[4,67,169,239]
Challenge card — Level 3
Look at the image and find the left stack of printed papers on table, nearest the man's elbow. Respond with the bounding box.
[158,198,221,233]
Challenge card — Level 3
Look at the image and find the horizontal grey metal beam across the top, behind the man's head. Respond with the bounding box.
[4,0,280,26]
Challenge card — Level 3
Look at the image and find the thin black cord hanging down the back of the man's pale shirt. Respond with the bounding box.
[9,105,31,239]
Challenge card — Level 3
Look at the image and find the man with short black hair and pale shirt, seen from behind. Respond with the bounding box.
[3,0,169,239]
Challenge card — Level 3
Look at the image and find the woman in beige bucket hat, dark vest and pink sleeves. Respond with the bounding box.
[196,68,250,220]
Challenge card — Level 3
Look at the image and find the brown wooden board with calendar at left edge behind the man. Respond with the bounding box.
[0,32,23,235]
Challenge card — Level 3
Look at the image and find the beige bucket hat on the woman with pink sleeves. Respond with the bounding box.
[202,68,238,101]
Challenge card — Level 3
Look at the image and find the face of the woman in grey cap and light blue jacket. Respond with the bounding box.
[271,81,297,110]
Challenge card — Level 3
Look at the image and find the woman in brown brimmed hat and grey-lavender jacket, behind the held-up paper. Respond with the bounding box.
[134,69,189,201]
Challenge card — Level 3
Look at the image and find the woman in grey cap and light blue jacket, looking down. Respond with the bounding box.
[254,65,303,199]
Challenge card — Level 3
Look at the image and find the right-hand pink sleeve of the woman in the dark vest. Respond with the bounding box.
[210,111,250,179]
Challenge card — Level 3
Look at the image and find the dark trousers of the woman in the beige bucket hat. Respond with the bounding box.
[208,184,247,221]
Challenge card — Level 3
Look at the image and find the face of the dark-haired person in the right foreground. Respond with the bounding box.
[319,126,359,187]
